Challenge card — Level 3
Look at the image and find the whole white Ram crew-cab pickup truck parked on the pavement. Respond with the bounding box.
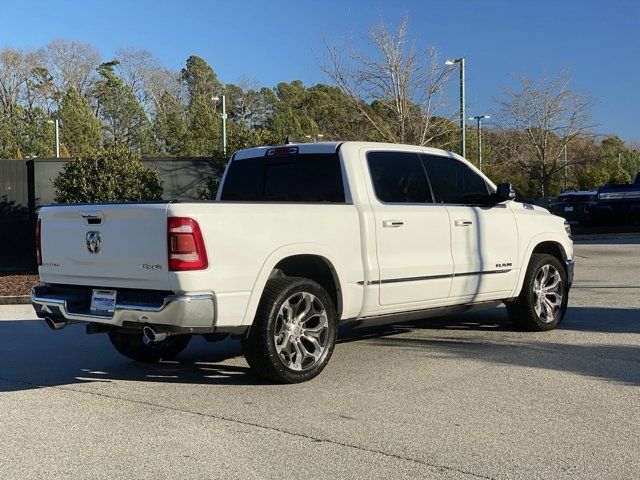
[32,142,573,382]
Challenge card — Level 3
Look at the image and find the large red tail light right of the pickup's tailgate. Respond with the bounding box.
[167,217,209,272]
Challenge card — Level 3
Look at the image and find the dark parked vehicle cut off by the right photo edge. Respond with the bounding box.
[595,172,640,225]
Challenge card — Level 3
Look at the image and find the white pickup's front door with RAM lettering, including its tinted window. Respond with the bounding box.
[422,155,518,301]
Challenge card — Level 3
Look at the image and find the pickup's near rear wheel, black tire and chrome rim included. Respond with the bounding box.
[242,277,337,383]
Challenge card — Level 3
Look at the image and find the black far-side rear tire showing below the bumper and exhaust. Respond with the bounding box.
[109,330,191,363]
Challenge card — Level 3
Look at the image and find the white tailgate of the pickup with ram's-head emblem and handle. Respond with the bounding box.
[39,203,170,290]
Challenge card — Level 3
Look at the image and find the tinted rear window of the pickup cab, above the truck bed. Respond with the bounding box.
[220,153,345,203]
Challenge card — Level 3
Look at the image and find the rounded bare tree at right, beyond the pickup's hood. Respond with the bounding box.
[497,72,596,201]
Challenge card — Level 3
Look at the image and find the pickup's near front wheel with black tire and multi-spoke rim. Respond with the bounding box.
[507,253,569,332]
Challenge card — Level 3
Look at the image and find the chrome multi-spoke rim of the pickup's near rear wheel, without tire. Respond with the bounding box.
[274,292,329,371]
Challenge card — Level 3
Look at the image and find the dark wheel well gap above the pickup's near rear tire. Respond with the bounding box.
[270,255,342,318]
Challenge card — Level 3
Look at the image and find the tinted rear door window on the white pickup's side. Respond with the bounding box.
[367,152,432,203]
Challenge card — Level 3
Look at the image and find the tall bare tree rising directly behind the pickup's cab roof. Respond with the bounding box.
[319,16,456,146]
